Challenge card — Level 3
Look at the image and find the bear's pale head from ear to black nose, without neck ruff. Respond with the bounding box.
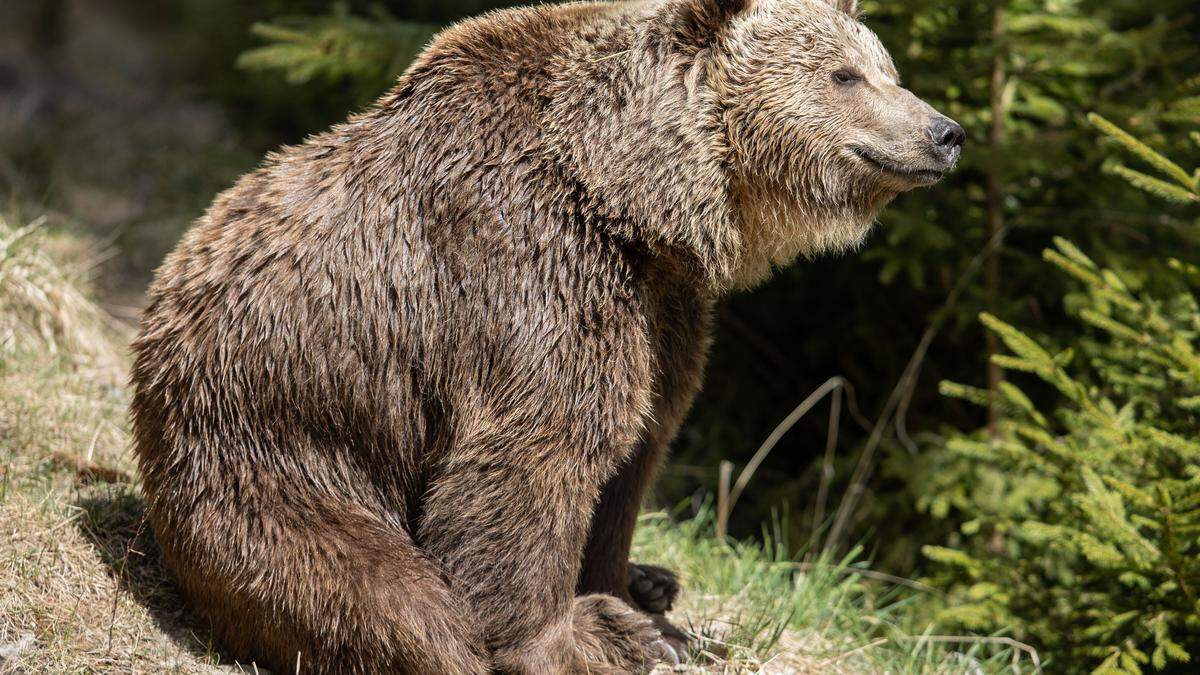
[692,0,965,285]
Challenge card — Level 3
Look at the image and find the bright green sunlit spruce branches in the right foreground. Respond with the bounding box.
[925,123,1200,673]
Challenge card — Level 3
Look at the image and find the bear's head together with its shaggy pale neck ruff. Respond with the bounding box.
[544,0,964,289]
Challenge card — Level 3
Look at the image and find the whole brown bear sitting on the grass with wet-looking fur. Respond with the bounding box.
[133,0,962,675]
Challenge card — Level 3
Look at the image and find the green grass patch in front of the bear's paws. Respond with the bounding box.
[634,512,1034,674]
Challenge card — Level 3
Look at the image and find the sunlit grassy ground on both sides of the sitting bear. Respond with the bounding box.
[0,211,1032,673]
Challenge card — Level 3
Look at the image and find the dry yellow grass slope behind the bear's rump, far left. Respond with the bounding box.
[0,213,231,673]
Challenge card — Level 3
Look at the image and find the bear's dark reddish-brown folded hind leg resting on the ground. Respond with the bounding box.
[155,502,490,675]
